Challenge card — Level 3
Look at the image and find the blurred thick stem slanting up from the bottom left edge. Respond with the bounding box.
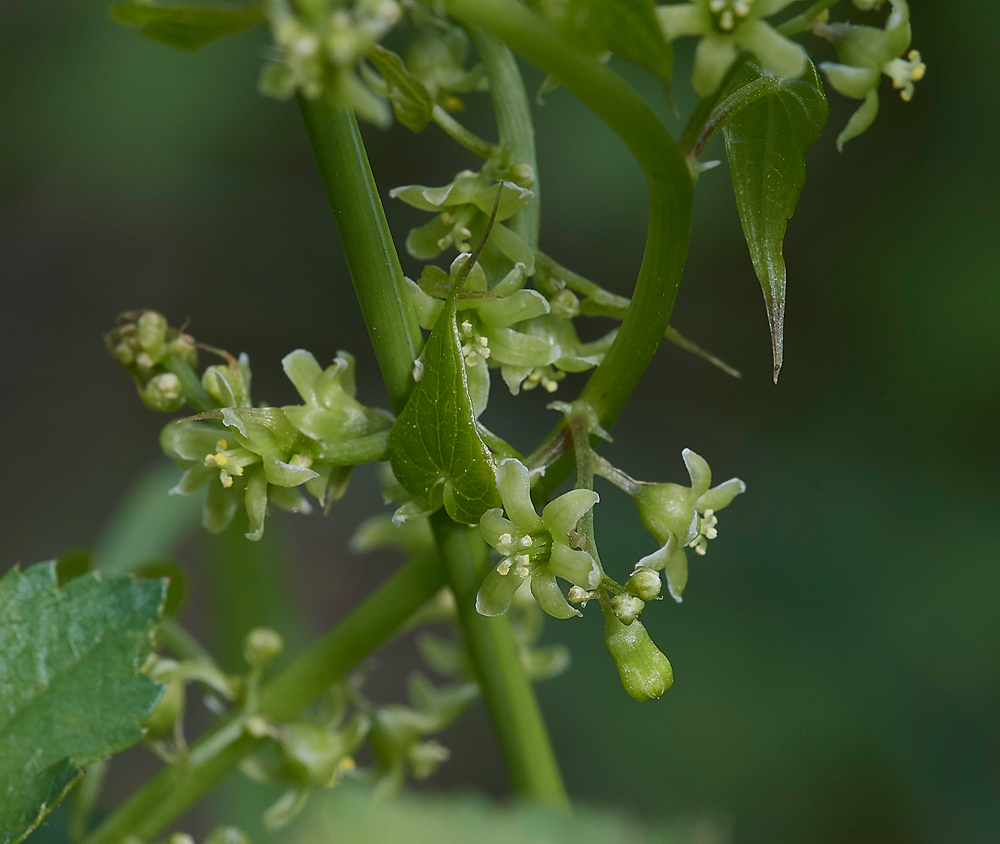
[84,557,444,844]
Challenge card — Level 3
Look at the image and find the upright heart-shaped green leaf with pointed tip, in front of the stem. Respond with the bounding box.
[389,280,502,525]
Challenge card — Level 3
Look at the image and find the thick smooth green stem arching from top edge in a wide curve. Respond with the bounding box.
[446,0,692,428]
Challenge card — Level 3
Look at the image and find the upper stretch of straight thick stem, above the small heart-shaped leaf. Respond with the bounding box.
[299,97,423,413]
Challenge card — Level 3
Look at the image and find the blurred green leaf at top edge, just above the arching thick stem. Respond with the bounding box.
[542,0,674,85]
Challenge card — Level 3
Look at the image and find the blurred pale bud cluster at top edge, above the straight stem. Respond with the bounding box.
[259,0,402,125]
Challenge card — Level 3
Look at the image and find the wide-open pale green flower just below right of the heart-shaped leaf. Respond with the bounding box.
[476,458,601,618]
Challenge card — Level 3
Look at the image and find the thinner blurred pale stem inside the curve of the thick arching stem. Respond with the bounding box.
[469,27,542,249]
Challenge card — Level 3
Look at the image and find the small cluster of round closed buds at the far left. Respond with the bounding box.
[104,311,198,413]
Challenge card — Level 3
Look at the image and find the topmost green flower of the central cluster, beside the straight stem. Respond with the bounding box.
[389,168,535,268]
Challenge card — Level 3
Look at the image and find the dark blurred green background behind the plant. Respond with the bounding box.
[0,0,1000,844]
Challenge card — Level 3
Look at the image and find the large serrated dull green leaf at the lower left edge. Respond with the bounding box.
[0,563,166,844]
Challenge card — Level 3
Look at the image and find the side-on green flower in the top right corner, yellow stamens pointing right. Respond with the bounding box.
[813,0,927,150]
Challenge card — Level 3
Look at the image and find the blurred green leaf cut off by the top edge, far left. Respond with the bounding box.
[111,3,265,50]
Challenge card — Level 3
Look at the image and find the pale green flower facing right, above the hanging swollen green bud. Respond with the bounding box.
[635,448,746,603]
